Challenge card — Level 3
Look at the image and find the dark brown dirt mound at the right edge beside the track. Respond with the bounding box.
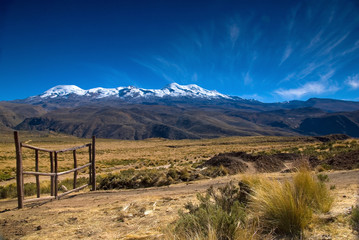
[325,151,359,170]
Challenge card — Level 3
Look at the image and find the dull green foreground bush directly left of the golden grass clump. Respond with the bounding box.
[174,183,246,240]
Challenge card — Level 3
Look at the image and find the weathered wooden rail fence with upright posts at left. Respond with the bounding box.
[14,131,96,208]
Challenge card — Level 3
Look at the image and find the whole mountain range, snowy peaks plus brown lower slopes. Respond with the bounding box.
[0,83,359,139]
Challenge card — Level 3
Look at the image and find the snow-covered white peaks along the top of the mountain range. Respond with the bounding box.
[38,83,231,99]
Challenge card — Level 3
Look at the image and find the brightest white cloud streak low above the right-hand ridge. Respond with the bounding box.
[275,82,339,100]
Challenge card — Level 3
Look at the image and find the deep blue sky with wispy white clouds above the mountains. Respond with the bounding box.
[0,0,359,102]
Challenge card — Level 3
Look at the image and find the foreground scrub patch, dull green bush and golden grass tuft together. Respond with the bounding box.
[170,170,333,240]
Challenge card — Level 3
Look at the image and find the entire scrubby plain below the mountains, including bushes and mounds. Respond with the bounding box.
[0,132,359,240]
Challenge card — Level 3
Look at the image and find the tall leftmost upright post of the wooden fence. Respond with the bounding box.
[14,131,24,208]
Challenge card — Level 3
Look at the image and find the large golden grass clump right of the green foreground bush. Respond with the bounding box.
[250,170,333,235]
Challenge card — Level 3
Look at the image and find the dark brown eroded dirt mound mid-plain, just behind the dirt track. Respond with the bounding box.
[203,152,300,174]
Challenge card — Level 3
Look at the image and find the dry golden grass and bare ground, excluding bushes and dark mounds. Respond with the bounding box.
[0,132,359,239]
